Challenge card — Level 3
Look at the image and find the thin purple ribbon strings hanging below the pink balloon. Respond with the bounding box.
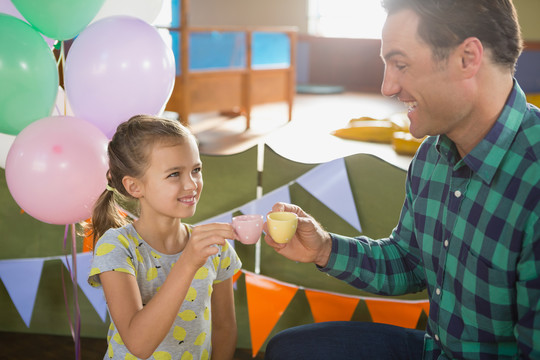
[61,224,81,360]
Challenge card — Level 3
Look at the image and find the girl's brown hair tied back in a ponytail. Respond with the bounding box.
[86,115,193,245]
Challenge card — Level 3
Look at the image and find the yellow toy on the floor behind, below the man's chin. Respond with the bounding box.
[332,113,424,155]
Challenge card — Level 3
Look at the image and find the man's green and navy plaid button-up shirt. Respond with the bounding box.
[322,82,540,359]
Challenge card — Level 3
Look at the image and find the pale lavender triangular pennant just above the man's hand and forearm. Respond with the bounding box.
[296,158,362,231]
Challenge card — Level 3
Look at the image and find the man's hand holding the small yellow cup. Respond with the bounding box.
[263,202,332,267]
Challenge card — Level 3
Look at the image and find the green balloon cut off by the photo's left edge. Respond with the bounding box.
[0,14,58,135]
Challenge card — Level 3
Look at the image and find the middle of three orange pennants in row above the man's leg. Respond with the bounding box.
[305,289,360,322]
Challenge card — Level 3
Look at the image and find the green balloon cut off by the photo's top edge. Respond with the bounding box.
[12,0,105,40]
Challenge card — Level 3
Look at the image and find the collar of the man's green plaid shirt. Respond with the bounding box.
[437,79,527,184]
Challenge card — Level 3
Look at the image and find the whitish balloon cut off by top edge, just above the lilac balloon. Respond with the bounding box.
[91,0,163,24]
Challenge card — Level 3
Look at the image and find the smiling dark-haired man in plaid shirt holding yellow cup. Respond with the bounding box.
[265,0,540,360]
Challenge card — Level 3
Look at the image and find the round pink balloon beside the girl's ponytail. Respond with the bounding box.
[6,116,108,225]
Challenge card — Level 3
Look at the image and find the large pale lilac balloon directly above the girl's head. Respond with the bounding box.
[64,16,176,138]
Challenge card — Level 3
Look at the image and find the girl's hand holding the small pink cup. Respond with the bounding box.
[181,223,236,270]
